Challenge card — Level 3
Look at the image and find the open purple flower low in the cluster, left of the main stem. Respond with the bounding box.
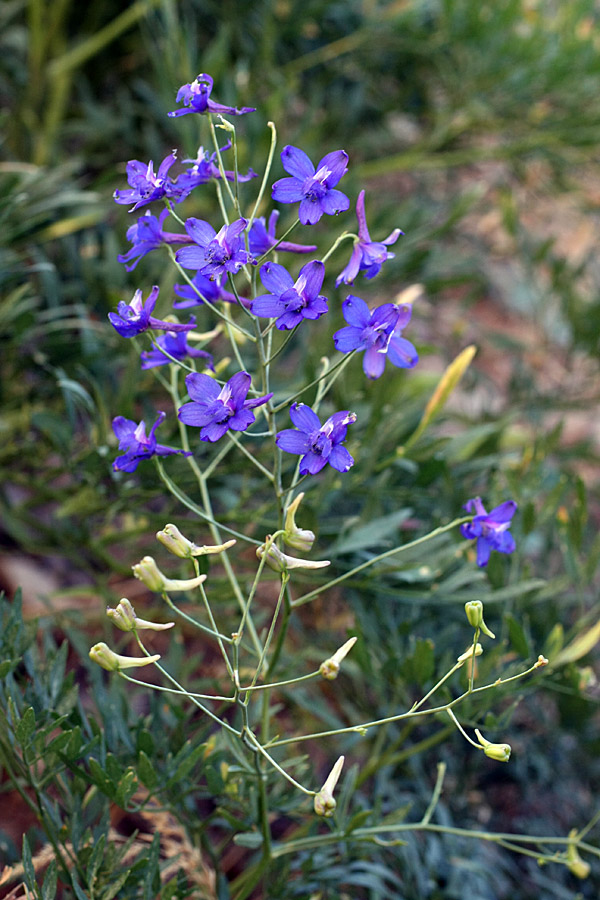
[178,372,273,442]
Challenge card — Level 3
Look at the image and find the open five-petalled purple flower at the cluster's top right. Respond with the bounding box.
[271,145,350,225]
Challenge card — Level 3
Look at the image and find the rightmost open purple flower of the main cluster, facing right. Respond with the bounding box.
[333,294,419,378]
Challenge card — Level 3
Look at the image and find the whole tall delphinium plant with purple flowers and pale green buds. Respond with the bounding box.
[79,74,590,900]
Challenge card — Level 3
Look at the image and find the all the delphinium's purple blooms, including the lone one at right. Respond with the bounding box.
[109,73,516,566]
